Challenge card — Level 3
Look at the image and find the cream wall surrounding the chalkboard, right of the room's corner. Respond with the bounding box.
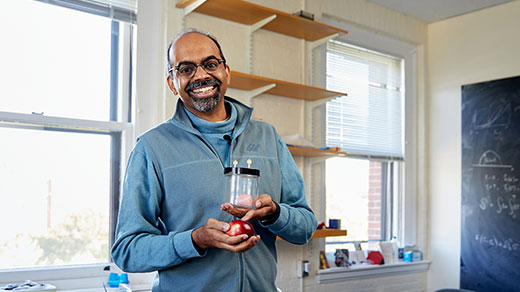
[428,1,520,291]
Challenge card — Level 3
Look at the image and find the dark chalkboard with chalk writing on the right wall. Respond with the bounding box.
[460,76,520,292]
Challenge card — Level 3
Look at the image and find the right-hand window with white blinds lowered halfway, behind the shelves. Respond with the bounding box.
[325,40,405,253]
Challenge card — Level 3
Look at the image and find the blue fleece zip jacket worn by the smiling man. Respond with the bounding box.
[112,97,317,292]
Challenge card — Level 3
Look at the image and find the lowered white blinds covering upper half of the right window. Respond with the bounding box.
[325,40,404,160]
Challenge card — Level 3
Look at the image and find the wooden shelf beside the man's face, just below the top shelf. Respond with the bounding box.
[229,71,347,100]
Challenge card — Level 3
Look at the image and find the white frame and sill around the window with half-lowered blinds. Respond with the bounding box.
[313,16,420,282]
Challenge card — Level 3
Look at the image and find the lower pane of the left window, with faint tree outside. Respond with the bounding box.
[0,127,110,269]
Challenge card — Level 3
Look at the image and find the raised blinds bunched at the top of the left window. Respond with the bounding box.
[36,0,137,23]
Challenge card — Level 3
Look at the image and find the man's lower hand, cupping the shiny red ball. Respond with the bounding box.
[191,218,260,253]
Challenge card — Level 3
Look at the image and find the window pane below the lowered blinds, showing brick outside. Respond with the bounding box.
[326,158,382,248]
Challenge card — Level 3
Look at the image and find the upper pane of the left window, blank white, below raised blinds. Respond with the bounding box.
[0,0,111,121]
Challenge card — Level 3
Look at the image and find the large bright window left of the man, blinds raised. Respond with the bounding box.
[0,0,136,274]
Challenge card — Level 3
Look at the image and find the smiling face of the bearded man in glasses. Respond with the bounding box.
[167,33,230,121]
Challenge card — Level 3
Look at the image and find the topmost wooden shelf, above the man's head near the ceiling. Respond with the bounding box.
[177,0,348,41]
